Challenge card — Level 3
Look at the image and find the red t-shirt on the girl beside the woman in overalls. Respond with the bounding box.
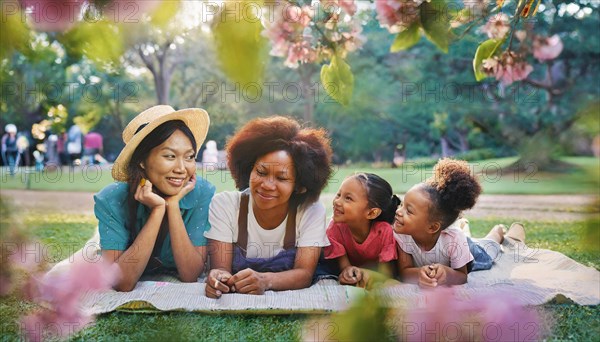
[325,221,398,267]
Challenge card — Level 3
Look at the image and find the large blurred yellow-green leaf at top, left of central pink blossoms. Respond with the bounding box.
[213,0,267,89]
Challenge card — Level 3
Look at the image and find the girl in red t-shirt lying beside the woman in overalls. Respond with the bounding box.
[325,173,400,285]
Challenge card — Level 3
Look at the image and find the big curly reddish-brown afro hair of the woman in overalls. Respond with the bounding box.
[225,116,333,205]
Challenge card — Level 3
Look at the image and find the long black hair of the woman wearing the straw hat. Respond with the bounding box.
[127,120,197,244]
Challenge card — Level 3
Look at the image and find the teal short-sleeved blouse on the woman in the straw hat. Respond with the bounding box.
[94,177,215,269]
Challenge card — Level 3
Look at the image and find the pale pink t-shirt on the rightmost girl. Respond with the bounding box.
[394,226,473,269]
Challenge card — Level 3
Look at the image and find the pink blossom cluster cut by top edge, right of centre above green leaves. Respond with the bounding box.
[375,0,424,33]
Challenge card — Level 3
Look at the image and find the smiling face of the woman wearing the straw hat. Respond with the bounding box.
[142,130,196,196]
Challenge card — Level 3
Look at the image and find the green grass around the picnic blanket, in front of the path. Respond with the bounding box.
[0,213,600,341]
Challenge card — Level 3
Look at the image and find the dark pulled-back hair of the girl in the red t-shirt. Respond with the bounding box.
[350,172,400,223]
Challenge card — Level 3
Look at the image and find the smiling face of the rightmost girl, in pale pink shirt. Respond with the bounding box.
[394,185,432,242]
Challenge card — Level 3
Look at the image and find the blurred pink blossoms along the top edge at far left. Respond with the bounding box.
[18,0,162,32]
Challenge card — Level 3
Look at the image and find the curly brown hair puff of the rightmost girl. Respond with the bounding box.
[420,158,481,229]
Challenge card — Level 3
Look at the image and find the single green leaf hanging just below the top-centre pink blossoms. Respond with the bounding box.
[321,56,354,106]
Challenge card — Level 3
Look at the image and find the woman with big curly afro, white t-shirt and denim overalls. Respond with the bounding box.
[205,116,332,298]
